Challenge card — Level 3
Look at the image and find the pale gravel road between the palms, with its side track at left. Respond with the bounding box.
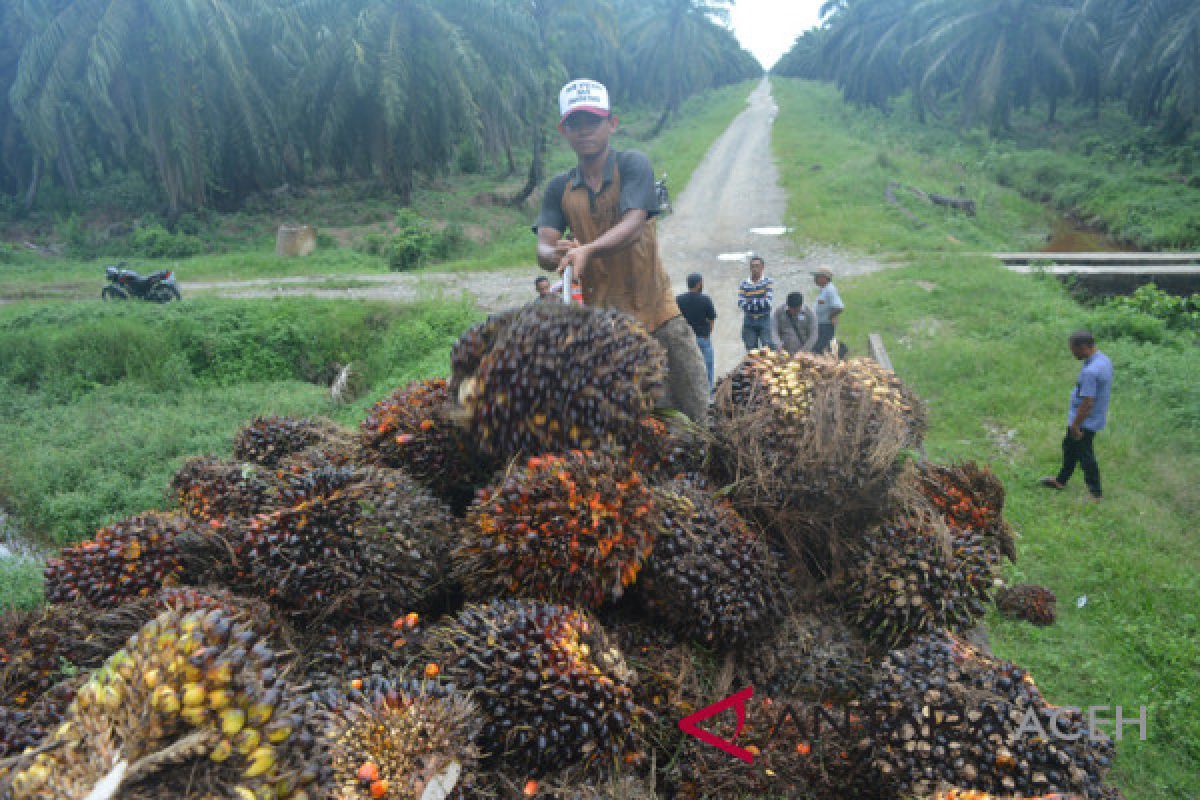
[181,80,882,374]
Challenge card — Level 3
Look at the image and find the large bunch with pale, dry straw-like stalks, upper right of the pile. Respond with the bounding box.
[710,348,919,577]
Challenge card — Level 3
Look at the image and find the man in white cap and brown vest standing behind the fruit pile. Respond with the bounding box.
[534,80,708,422]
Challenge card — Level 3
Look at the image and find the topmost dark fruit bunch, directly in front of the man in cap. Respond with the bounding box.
[450,303,666,461]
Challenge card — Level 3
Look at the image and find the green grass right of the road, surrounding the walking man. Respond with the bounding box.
[775,80,1200,800]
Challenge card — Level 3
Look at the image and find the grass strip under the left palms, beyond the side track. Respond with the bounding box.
[0,83,754,297]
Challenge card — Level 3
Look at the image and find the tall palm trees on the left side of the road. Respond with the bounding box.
[0,0,761,212]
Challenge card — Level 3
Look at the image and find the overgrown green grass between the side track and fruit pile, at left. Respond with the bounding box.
[0,299,476,546]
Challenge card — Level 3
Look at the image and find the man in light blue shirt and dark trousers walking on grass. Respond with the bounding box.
[1040,331,1112,500]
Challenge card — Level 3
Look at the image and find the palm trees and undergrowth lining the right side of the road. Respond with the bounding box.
[773,0,1200,249]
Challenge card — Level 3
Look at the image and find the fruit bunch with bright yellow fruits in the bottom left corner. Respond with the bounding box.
[12,609,322,800]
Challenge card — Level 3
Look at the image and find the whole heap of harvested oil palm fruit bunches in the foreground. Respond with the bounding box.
[0,303,1132,800]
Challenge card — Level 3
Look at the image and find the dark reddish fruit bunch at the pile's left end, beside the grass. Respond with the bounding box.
[44,512,196,606]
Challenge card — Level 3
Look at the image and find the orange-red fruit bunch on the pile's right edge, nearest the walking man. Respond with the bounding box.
[917,461,1016,561]
